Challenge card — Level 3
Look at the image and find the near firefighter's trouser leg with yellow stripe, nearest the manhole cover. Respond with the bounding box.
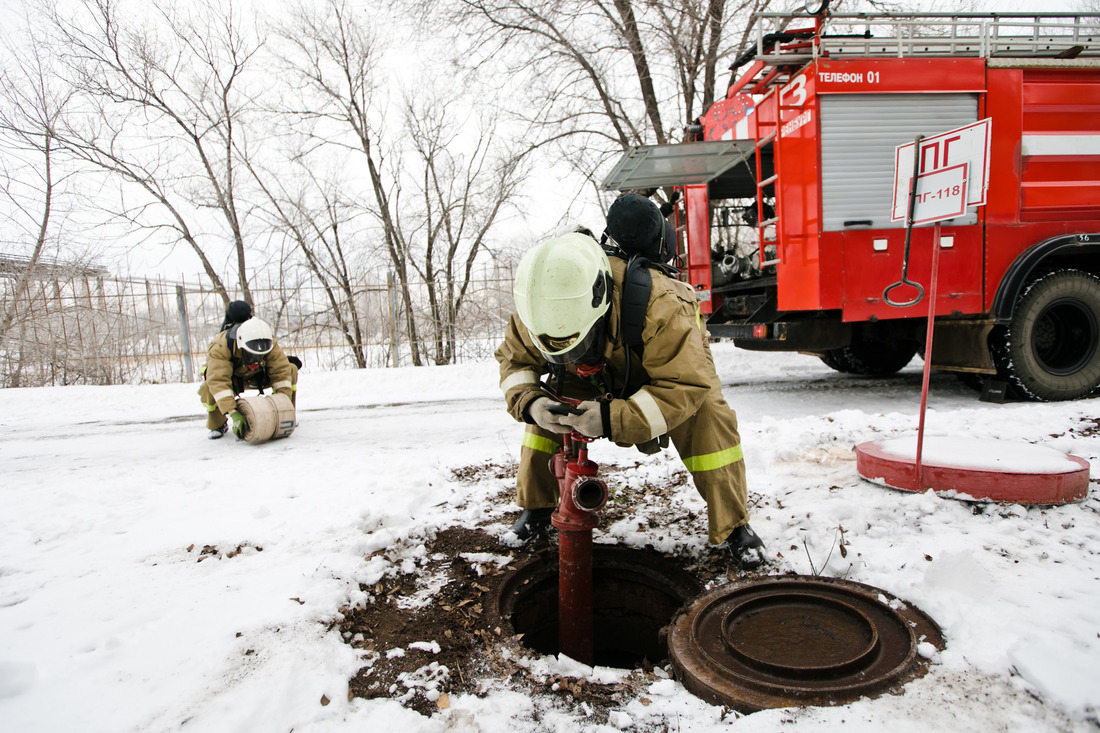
[669,390,749,545]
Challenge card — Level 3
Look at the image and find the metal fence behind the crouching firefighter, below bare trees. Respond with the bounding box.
[0,270,512,387]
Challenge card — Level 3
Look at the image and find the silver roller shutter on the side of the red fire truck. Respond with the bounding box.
[820,94,978,231]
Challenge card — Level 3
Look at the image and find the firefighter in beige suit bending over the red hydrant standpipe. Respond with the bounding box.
[496,233,763,569]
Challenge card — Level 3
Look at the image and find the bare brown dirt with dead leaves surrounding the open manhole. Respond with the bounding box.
[340,463,743,721]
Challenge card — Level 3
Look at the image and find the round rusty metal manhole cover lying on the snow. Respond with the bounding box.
[669,576,944,712]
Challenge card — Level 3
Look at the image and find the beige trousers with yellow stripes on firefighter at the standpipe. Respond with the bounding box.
[516,380,748,545]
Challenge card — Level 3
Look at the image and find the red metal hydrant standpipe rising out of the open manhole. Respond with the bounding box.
[550,431,607,665]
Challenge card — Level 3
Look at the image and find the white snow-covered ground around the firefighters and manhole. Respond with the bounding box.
[0,344,1100,733]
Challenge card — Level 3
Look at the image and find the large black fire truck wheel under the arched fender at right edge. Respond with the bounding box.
[992,270,1100,402]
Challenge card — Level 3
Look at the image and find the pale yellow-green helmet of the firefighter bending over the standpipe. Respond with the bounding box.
[513,232,612,364]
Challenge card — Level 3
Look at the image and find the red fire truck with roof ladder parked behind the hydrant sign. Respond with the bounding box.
[603,3,1100,400]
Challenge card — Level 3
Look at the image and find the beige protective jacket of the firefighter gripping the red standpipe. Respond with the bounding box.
[496,258,721,444]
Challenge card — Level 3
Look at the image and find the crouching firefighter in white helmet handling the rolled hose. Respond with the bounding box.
[199,300,300,439]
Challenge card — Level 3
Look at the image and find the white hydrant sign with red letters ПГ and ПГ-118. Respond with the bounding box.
[891,118,990,223]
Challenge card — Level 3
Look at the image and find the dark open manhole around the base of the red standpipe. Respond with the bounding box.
[499,545,702,669]
